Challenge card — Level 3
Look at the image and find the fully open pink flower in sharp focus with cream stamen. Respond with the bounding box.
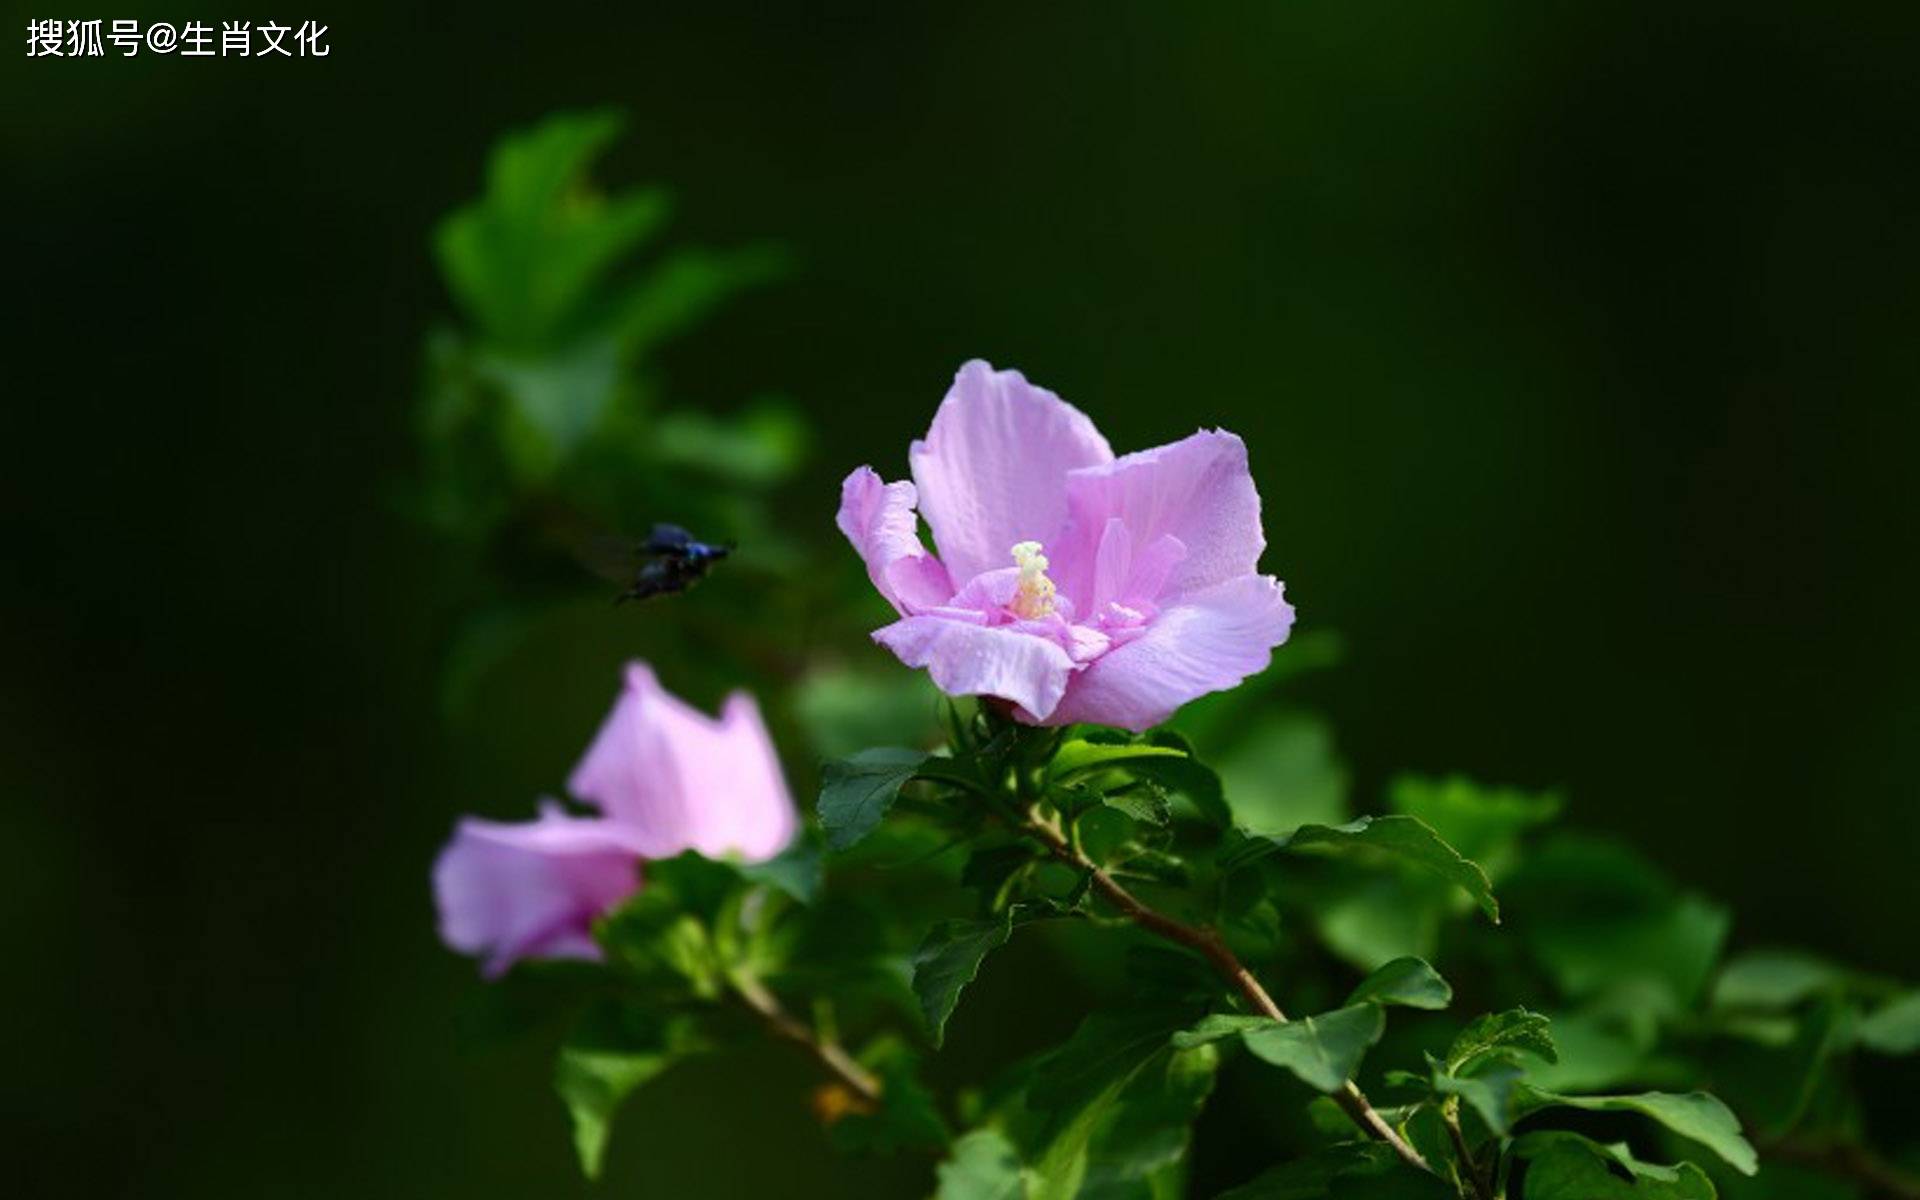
[837,361,1294,732]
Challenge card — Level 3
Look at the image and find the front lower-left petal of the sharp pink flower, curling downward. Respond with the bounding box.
[874,616,1073,718]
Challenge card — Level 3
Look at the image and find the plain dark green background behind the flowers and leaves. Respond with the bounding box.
[0,2,1920,1196]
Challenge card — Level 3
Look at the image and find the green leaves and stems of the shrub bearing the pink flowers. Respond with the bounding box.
[415,113,1920,1200]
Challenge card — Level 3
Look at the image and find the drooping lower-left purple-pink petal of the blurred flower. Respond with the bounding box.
[434,804,639,977]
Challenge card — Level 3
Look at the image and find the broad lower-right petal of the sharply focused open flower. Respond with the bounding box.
[1033,576,1294,732]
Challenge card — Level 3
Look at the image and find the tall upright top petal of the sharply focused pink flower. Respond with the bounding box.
[908,359,1114,580]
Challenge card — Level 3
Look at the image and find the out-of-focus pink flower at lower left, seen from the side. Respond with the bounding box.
[434,662,799,977]
